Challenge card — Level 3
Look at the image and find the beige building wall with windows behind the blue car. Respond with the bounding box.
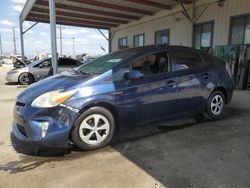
[111,0,250,51]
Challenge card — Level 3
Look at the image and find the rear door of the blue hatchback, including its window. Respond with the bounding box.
[173,49,209,112]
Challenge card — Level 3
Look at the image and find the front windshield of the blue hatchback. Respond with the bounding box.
[75,50,137,74]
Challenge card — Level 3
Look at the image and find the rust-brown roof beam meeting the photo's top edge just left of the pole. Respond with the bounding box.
[35,0,140,20]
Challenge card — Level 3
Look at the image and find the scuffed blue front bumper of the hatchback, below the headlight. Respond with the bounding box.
[11,102,78,151]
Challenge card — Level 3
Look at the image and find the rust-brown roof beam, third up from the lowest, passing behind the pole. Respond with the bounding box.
[30,7,128,24]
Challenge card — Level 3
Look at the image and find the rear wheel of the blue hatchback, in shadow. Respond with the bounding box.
[204,91,225,120]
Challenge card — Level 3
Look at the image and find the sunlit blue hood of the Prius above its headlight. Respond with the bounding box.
[17,72,94,105]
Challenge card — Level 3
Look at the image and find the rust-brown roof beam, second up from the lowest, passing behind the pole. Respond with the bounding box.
[28,13,117,27]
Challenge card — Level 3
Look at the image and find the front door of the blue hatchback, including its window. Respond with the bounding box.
[124,51,180,123]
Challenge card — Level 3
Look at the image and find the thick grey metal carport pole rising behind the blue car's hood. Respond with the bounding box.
[49,0,57,74]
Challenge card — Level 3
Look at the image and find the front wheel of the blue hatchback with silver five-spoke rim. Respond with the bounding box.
[71,107,115,150]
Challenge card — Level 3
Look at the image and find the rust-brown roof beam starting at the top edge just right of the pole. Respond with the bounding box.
[69,0,154,16]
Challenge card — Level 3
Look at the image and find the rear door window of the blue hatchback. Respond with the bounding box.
[174,50,203,71]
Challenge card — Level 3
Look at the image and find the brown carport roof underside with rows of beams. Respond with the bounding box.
[21,0,192,29]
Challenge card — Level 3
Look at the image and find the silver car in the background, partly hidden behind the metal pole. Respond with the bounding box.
[6,58,82,85]
